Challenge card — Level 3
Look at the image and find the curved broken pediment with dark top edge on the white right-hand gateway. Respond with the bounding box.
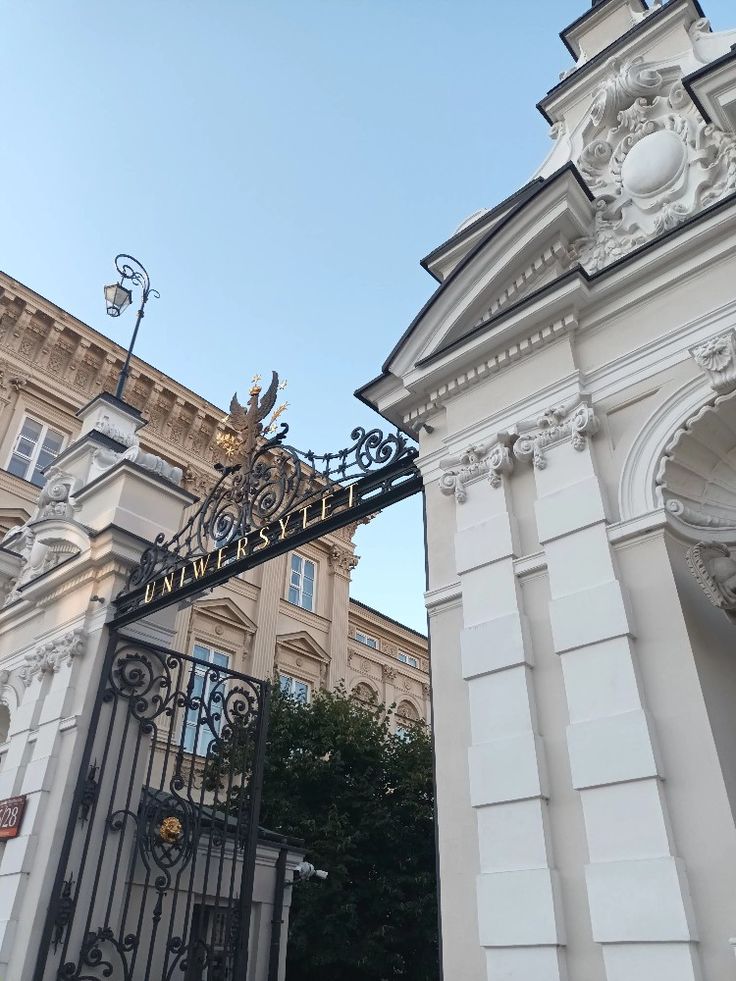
[392,164,593,376]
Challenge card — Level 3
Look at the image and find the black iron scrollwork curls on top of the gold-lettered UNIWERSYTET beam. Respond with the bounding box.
[126,412,417,591]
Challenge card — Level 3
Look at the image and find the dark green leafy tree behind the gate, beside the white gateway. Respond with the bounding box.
[261,686,439,981]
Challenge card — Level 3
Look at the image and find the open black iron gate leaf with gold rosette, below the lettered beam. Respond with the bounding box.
[36,635,269,981]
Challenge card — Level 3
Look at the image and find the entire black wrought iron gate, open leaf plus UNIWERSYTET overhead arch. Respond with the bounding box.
[33,372,422,981]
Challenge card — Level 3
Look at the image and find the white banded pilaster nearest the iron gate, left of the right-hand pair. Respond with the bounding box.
[445,468,566,981]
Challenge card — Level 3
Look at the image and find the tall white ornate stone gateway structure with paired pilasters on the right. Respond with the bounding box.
[359,0,736,981]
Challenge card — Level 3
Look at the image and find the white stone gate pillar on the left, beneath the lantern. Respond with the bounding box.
[0,396,192,979]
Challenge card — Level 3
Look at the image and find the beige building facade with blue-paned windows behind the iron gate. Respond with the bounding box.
[0,273,430,728]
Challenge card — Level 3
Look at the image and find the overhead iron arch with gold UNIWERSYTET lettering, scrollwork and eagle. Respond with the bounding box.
[115,372,422,627]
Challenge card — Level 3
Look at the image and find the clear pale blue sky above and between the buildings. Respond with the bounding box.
[0,0,736,629]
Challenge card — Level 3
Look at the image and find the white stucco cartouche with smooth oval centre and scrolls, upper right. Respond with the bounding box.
[571,57,736,272]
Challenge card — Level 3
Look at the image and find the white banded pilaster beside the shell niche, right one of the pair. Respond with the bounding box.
[519,404,700,981]
